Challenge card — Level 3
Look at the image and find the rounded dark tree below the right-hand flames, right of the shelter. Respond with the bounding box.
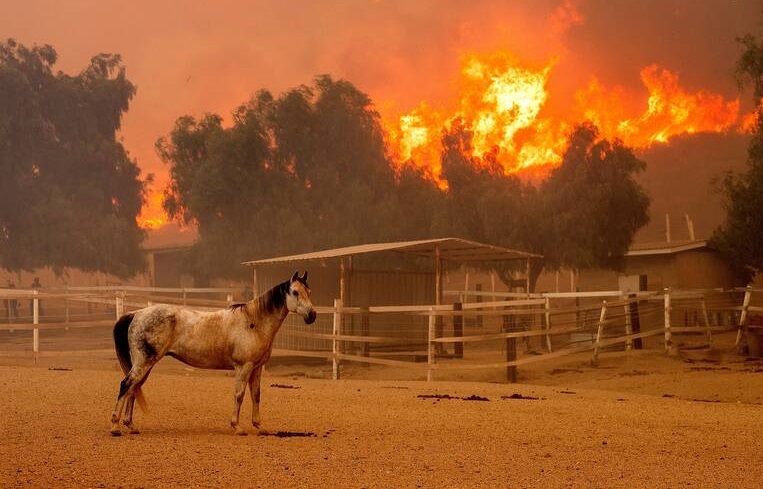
[538,123,649,282]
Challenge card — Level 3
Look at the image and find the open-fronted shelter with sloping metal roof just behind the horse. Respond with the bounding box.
[244,238,539,355]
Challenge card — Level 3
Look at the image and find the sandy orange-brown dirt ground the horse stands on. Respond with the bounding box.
[0,330,763,488]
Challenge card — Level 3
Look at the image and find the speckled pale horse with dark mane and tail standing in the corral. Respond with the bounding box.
[111,272,316,436]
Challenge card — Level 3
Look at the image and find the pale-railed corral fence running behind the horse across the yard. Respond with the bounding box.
[0,287,763,381]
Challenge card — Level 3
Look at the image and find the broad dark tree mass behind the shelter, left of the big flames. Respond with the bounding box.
[157,75,435,278]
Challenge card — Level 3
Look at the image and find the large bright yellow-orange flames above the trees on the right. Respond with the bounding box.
[385,53,749,188]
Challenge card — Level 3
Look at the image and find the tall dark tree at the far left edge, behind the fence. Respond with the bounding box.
[0,39,146,277]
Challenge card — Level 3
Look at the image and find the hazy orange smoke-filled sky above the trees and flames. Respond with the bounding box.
[0,0,763,229]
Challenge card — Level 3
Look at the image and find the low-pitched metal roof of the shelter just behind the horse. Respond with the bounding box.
[243,238,541,266]
